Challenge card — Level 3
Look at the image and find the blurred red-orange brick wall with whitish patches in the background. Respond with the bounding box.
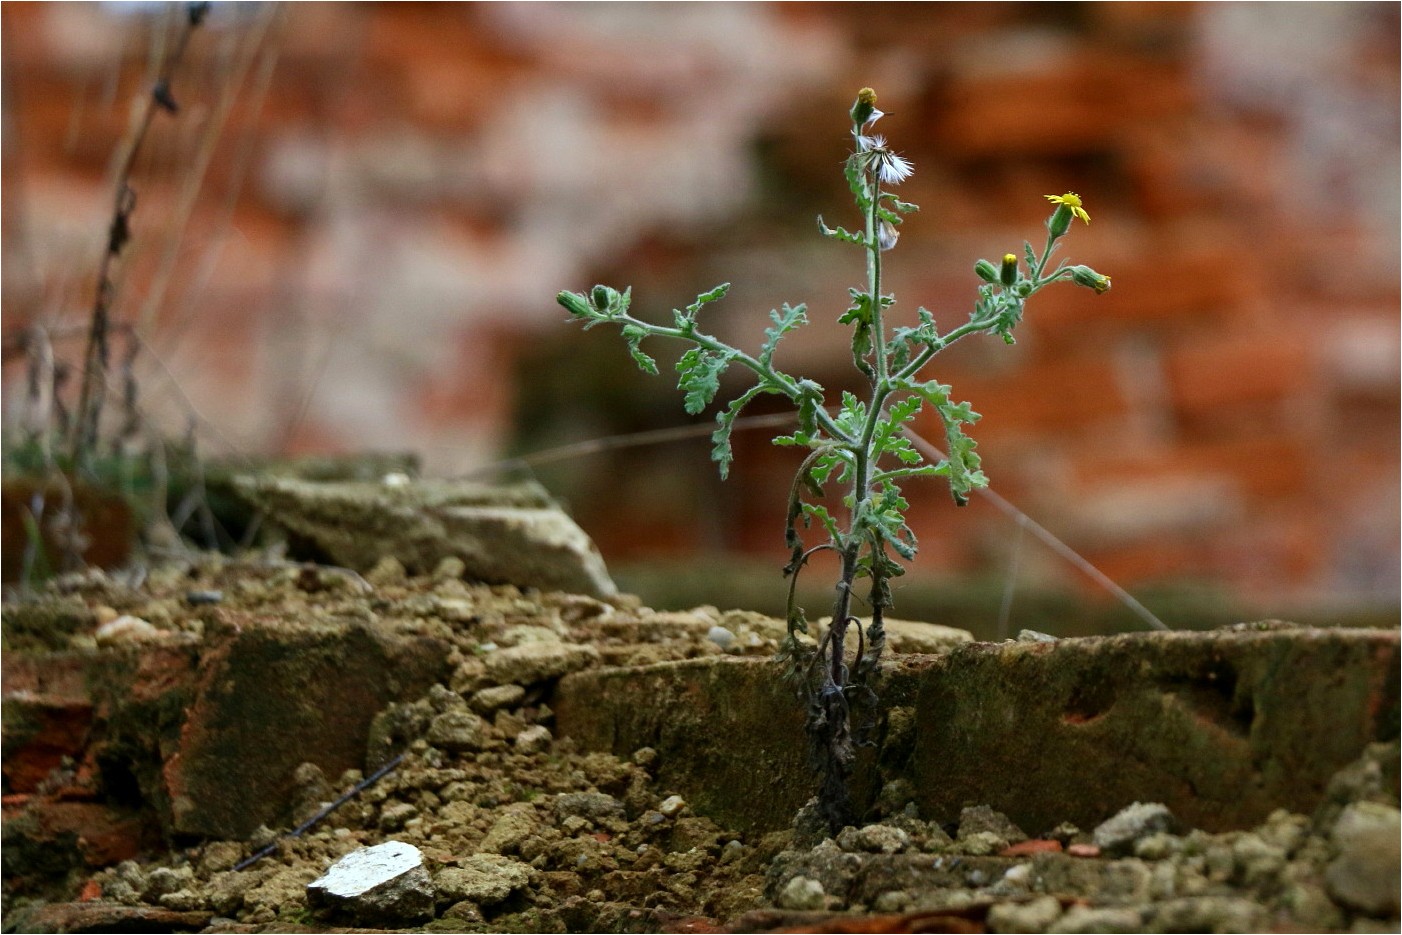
[0,3,1399,611]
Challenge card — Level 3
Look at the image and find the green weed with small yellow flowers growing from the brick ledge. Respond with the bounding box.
[557,88,1110,831]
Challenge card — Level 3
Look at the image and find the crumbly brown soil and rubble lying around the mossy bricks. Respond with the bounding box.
[4,557,1398,932]
